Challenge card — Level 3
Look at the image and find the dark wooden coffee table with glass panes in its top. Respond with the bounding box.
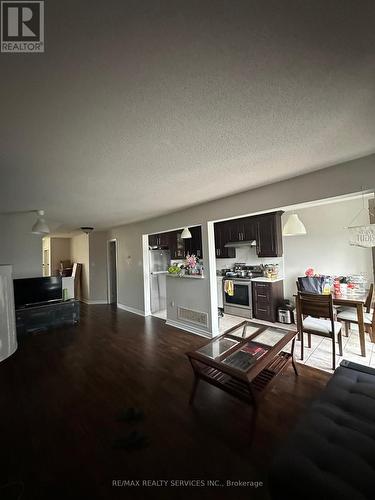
[186,321,298,409]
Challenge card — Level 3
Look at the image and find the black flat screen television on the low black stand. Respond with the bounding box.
[13,276,62,309]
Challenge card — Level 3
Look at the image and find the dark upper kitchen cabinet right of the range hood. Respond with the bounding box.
[255,211,283,257]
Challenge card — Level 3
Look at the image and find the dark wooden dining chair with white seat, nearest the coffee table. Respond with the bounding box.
[297,292,342,370]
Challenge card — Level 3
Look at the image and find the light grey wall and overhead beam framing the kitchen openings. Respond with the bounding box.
[110,155,375,332]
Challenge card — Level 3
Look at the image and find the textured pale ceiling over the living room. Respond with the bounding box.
[0,0,375,230]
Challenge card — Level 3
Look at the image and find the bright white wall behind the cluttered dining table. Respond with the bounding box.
[283,199,373,298]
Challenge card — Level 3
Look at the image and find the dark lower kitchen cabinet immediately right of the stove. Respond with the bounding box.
[252,280,284,323]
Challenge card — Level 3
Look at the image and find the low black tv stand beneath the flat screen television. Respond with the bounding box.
[16,299,79,337]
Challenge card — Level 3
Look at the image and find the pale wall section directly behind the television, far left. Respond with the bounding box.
[0,214,42,278]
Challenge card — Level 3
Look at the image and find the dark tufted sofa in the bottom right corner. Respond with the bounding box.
[270,361,375,500]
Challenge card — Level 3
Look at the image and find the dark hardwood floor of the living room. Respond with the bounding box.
[0,305,329,500]
